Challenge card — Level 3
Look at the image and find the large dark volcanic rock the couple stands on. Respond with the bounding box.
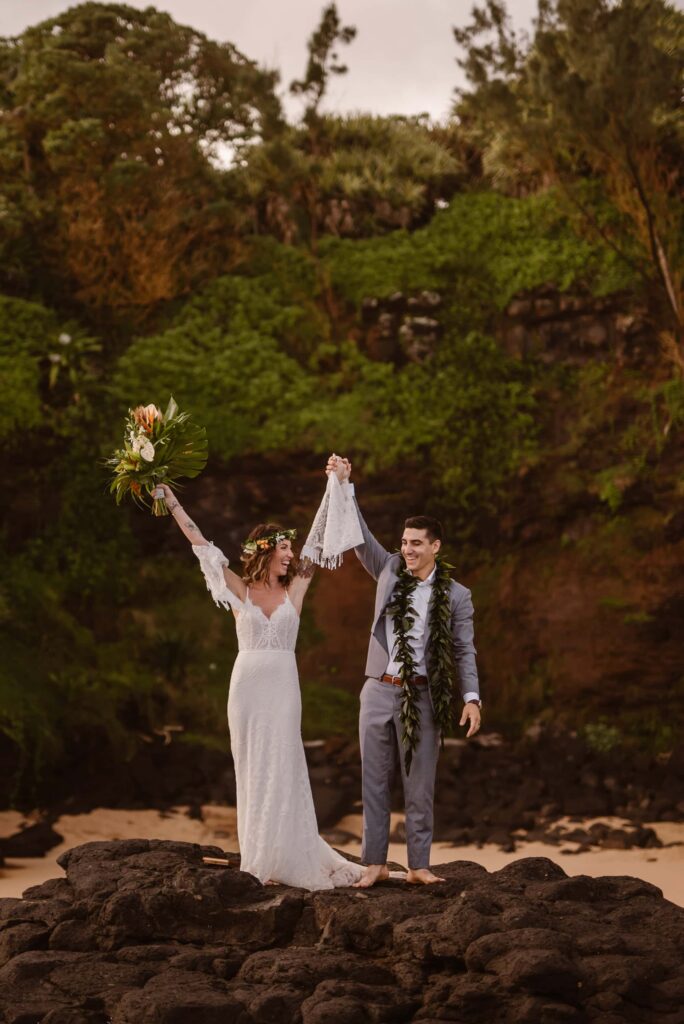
[0,840,684,1024]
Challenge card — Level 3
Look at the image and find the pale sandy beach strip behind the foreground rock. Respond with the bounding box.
[0,804,684,906]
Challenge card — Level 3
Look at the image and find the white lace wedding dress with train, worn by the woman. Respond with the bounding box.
[193,544,361,889]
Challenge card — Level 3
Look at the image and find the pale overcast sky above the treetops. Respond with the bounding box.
[0,0,537,120]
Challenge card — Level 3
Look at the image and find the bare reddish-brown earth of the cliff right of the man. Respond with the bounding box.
[474,501,684,729]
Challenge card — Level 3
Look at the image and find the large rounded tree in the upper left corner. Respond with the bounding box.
[0,3,281,309]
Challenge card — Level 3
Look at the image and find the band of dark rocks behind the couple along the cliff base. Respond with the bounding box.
[5,731,684,864]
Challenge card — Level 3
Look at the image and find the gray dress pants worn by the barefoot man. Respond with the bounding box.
[358,679,439,869]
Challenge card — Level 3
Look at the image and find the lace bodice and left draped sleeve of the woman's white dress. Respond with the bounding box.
[193,544,299,651]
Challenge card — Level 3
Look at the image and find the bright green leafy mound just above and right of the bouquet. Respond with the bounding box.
[112,278,312,459]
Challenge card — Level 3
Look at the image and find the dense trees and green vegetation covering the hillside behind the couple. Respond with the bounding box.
[0,0,684,800]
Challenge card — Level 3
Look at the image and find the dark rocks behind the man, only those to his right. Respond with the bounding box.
[432,730,684,849]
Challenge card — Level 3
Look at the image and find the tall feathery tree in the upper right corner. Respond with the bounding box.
[455,0,684,368]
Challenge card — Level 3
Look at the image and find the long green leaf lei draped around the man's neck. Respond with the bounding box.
[387,557,456,775]
